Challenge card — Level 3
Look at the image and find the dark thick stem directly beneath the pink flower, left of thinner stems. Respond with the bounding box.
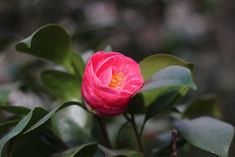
[95,116,111,148]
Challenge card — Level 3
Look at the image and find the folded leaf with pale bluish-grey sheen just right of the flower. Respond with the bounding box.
[141,66,196,121]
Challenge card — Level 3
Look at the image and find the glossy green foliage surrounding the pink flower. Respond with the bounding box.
[0,24,234,157]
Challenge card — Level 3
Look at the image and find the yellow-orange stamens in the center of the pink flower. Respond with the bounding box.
[108,72,126,88]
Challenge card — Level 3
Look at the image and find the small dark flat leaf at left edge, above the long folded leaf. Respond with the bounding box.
[0,105,30,115]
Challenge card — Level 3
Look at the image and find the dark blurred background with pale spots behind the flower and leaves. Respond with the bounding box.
[0,0,235,156]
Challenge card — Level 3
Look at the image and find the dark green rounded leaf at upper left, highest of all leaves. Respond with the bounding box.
[16,24,71,65]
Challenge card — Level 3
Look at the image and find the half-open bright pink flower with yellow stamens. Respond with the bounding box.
[82,51,144,116]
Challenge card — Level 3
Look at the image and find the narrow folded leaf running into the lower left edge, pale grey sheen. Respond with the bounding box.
[0,108,46,156]
